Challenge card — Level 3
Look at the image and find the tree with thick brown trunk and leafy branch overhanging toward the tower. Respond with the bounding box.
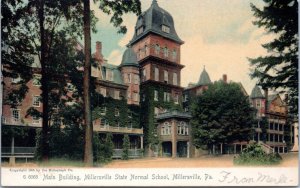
[83,0,141,166]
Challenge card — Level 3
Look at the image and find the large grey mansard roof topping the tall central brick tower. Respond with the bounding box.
[129,0,183,45]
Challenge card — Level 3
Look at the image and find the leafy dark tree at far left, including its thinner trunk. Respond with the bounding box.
[1,0,95,160]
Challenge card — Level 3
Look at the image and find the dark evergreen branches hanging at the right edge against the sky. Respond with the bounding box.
[249,0,299,114]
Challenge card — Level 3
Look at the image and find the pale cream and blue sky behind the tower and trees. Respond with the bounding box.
[91,0,274,95]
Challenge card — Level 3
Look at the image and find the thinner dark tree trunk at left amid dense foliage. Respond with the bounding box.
[39,0,49,161]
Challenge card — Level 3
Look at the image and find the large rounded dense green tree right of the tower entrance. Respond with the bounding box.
[191,81,254,153]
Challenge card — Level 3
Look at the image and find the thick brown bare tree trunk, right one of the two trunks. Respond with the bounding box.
[83,0,93,166]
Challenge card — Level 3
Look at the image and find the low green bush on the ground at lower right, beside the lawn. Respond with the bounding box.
[233,143,282,165]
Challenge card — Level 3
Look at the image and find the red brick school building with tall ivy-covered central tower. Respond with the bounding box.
[2,0,296,157]
